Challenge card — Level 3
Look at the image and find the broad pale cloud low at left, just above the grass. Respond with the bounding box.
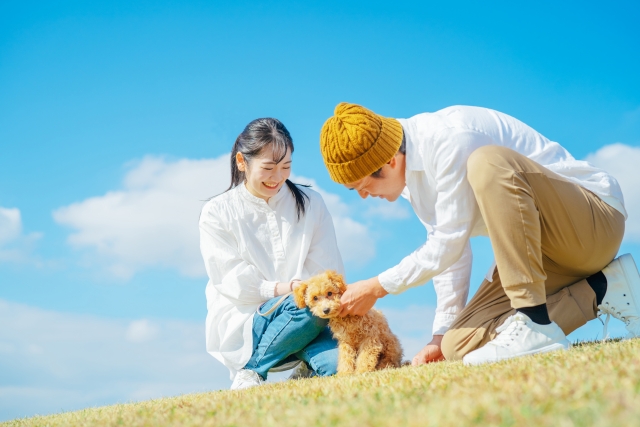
[0,300,230,420]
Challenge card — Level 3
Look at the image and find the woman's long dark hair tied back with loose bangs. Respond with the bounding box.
[225,118,309,220]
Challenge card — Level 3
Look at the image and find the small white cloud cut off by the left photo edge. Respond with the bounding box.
[0,206,41,262]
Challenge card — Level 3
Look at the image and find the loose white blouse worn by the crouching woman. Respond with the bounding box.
[200,185,344,379]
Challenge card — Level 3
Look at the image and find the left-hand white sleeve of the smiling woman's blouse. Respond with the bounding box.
[200,209,276,305]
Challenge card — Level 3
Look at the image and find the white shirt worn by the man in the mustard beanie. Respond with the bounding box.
[378,106,627,335]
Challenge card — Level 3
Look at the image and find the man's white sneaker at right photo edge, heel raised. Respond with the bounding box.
[598,254,640,339]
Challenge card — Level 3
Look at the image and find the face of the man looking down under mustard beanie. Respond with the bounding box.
[344,154,405,202]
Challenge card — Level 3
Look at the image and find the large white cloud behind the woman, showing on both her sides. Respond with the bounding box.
[53,155,375,279]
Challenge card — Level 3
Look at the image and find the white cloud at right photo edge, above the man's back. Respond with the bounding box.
[586,143,640,242]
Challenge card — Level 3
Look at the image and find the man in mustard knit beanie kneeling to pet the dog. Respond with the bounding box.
[320,103,640,365]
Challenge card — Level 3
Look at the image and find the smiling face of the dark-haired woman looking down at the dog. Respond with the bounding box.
[236,144,291,201]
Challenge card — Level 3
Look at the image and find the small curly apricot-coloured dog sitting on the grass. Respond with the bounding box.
[293,271,402,375]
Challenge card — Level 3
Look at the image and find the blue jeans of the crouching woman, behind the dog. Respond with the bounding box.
[244,295,338,379]
